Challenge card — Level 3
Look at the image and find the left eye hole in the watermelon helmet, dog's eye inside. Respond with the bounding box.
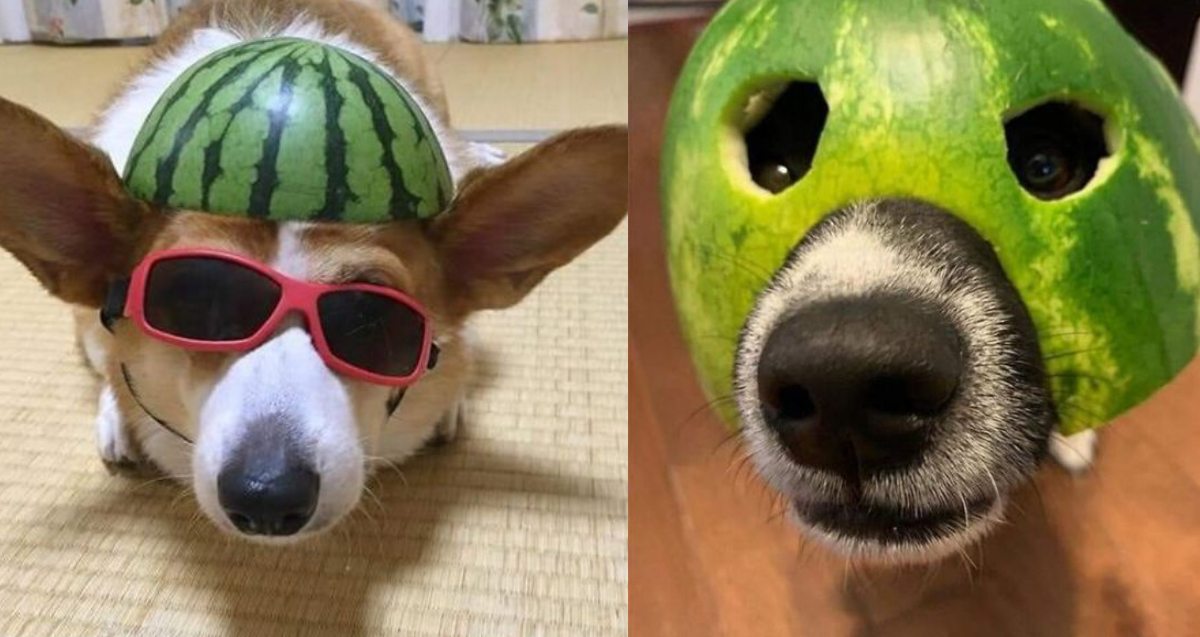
[745,82,829,194]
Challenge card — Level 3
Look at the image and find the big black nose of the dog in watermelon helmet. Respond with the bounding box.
[758,295,962,485]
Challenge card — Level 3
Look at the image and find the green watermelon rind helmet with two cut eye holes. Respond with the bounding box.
[661,0,1200,433]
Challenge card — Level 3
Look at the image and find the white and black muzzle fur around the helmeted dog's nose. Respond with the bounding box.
[734,202,1055,563]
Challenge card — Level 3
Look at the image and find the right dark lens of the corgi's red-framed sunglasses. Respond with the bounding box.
[317,290,425,378]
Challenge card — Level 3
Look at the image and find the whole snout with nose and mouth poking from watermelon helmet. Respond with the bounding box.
[736,200,1056,560]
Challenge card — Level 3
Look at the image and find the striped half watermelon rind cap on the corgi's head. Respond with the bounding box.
[125,37,454,223]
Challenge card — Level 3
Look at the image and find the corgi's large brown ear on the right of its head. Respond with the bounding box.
[431,126,629,312]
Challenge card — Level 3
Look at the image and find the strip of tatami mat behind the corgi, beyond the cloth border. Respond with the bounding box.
[0,40,629,130]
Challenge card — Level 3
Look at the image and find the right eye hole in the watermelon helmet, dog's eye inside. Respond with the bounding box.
[1004,102,1111,200]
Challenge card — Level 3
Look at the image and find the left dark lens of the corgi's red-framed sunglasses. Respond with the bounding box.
[143,257,282,342]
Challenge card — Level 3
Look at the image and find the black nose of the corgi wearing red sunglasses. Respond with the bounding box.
[217,453,320,535]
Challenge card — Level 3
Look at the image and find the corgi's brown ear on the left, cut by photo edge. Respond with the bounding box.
[0,98,161,307]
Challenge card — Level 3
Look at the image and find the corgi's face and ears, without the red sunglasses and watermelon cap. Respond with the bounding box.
[0,100,626,541]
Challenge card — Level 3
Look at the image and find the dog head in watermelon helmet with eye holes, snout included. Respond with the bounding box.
[662,0,1200,560]
